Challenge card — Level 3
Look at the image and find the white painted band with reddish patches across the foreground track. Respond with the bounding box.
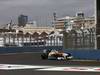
[0,64,100,72]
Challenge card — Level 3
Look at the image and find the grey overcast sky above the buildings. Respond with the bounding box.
[0,0,94,25]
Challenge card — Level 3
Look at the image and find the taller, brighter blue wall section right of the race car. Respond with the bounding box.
[64,49,100,60]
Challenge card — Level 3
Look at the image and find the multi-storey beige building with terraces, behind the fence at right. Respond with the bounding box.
[54,13,96,30]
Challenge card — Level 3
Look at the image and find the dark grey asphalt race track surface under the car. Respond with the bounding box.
[0,53,100,75]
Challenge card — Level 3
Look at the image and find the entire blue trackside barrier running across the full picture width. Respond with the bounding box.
[0,46,100,60]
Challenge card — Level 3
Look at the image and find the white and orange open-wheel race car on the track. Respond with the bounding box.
[41,50,73,60]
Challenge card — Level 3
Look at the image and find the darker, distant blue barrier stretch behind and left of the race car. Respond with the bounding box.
[0,46,63,54]
